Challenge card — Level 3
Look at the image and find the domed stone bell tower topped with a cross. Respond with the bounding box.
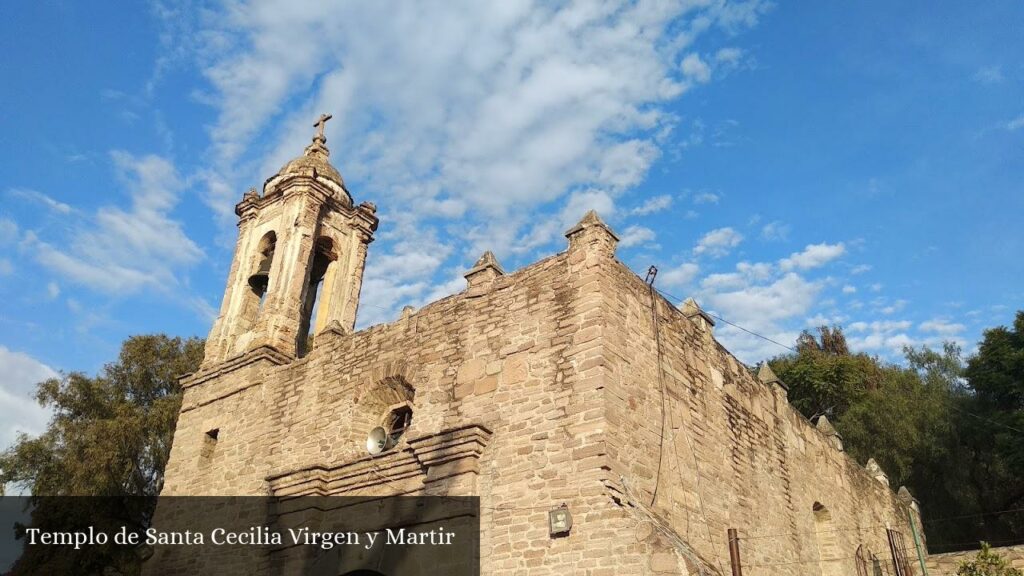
[203,115,377,367]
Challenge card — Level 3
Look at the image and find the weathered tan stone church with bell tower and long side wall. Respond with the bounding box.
[155,117,924,576]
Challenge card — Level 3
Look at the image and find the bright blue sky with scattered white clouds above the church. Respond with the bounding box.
[0,0,1024,445]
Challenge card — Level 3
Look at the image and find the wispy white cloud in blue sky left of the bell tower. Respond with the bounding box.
[27,152,203,294]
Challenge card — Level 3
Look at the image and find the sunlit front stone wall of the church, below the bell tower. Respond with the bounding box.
[164,234,671,575]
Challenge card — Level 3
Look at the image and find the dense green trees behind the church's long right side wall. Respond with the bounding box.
[770,323,1024,550]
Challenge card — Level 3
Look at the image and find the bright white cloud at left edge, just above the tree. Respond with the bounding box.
[0,346,57,450]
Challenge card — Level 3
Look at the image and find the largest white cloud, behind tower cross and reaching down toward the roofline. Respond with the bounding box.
[167,0,768,323]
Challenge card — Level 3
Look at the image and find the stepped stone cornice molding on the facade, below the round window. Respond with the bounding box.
[267,424,490,496]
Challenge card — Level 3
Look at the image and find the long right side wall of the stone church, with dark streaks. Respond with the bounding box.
[600,243,920,575]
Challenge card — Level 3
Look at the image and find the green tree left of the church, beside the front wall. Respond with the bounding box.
[0,334,203,574]
